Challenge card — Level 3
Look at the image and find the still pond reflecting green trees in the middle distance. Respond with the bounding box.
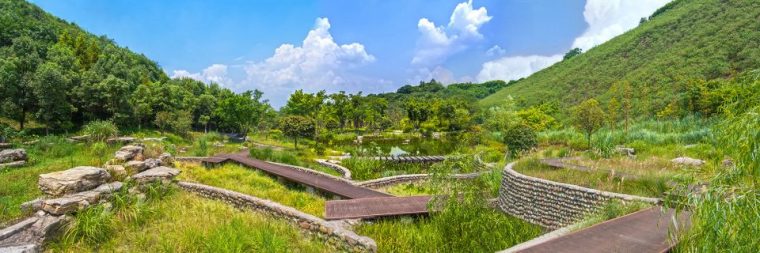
[335,134,462,156]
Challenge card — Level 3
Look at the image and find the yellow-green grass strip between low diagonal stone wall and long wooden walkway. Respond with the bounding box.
[177,163,325,217]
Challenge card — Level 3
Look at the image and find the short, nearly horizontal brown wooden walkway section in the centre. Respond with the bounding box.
[325,196,432,220]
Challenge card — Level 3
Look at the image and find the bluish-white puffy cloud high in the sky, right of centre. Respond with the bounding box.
[412,0,492,66]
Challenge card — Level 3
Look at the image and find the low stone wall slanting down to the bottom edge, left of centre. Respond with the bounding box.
[177,182,377,252]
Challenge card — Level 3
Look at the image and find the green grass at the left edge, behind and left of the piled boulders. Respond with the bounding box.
[0,137,119,227]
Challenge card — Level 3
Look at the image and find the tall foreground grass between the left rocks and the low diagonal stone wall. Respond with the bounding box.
[47,189,332,252]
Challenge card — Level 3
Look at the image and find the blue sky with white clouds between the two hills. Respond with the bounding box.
[32,0,669,107]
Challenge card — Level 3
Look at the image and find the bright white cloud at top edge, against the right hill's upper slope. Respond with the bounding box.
[572,0,670,51]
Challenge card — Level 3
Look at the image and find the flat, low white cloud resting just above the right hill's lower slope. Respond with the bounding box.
[477,55,562,82]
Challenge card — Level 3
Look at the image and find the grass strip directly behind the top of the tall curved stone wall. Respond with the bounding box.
[514,158,667,197]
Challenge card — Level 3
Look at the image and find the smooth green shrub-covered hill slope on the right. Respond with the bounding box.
[480,0,760,116]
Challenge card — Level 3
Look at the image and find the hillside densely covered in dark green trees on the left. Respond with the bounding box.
[0,0,273,134]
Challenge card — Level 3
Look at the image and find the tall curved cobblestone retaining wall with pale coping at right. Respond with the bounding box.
[498,163,660,229]
